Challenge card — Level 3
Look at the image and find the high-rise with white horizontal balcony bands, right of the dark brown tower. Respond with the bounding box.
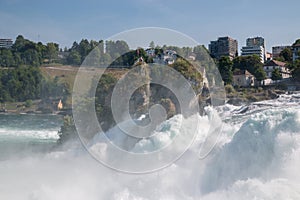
[241,37,266,63]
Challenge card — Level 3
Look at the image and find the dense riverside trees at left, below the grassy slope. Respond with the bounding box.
[0,67,70,103]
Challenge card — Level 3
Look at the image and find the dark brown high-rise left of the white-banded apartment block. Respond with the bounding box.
[208,37,238,59]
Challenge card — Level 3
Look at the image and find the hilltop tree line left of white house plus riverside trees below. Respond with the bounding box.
[0,35,134,102]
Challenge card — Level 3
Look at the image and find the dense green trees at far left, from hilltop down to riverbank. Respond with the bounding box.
[0,35,70,102]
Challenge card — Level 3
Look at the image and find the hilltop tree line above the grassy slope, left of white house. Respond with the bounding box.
[0,35,129,67]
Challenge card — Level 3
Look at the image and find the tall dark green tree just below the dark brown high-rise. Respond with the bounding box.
[218,56,233,85]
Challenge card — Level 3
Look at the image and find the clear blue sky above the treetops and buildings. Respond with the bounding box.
[0,0,300,50]
